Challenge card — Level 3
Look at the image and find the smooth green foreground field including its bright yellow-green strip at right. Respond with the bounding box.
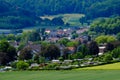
[0,63,120,80]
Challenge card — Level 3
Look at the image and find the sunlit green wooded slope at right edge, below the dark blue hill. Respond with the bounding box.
[90,16,120,34]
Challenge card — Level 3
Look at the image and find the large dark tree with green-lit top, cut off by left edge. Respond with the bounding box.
[0,40,17,65]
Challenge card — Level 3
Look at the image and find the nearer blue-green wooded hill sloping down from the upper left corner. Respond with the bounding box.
[0,0,37,29]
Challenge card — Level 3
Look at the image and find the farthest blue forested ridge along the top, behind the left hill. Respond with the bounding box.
[6,0,120,19]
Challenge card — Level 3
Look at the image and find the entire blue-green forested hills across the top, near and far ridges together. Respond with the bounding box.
[0,0,120,29]
